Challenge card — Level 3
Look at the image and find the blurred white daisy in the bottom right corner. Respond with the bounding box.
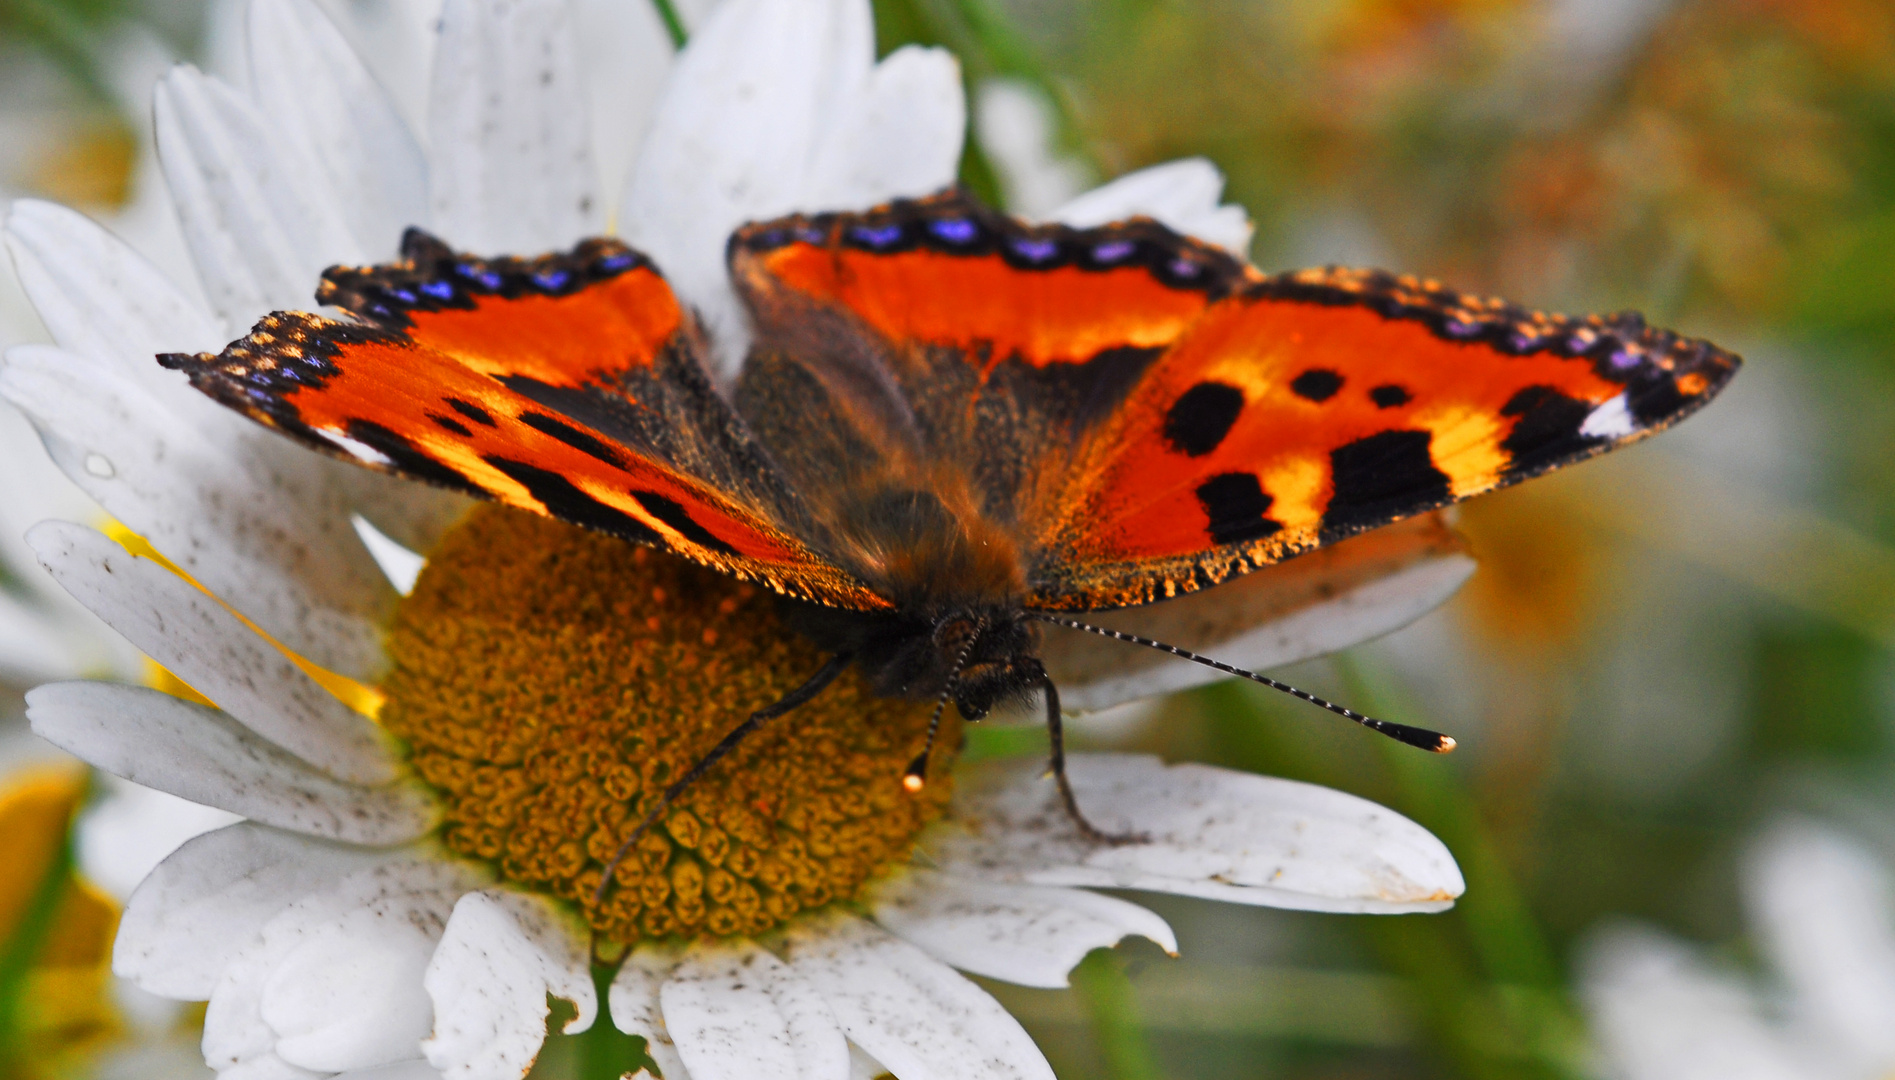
[1582,820,1895,1080]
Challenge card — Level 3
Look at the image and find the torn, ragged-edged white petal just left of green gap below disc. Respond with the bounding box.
[421,889,599,1080]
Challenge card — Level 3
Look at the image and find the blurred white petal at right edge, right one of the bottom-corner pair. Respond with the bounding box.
[1743,820,1895,1074]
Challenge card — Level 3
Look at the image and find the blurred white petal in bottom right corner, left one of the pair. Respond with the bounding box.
[1580,927,1825,1080]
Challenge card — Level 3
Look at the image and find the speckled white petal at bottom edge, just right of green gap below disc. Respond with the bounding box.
[659,938,849,1080]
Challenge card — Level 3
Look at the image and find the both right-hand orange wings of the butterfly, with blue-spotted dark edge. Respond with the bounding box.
[731,193,1738,610]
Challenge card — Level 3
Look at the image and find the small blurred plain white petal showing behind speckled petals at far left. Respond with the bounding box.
[72,775,239,898]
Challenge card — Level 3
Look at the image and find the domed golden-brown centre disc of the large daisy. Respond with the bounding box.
[381,508,959,932]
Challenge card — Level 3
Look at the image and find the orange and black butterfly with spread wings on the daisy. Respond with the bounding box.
[159,191,1740,856]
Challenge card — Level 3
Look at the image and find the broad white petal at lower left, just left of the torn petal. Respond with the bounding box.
[205,856,485,1072]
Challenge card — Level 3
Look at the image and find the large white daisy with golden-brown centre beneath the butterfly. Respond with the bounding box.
[0,0,1471,1080]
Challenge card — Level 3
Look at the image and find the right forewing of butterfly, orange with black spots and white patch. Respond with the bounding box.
[1029,269,1740,608]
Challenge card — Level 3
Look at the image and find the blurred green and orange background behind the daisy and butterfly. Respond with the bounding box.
[0,0,1895,1080]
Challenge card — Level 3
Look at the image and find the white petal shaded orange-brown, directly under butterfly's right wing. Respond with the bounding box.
[1044,517,1474,712]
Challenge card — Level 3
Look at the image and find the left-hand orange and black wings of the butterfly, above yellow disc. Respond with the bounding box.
[159,229,887,610]
